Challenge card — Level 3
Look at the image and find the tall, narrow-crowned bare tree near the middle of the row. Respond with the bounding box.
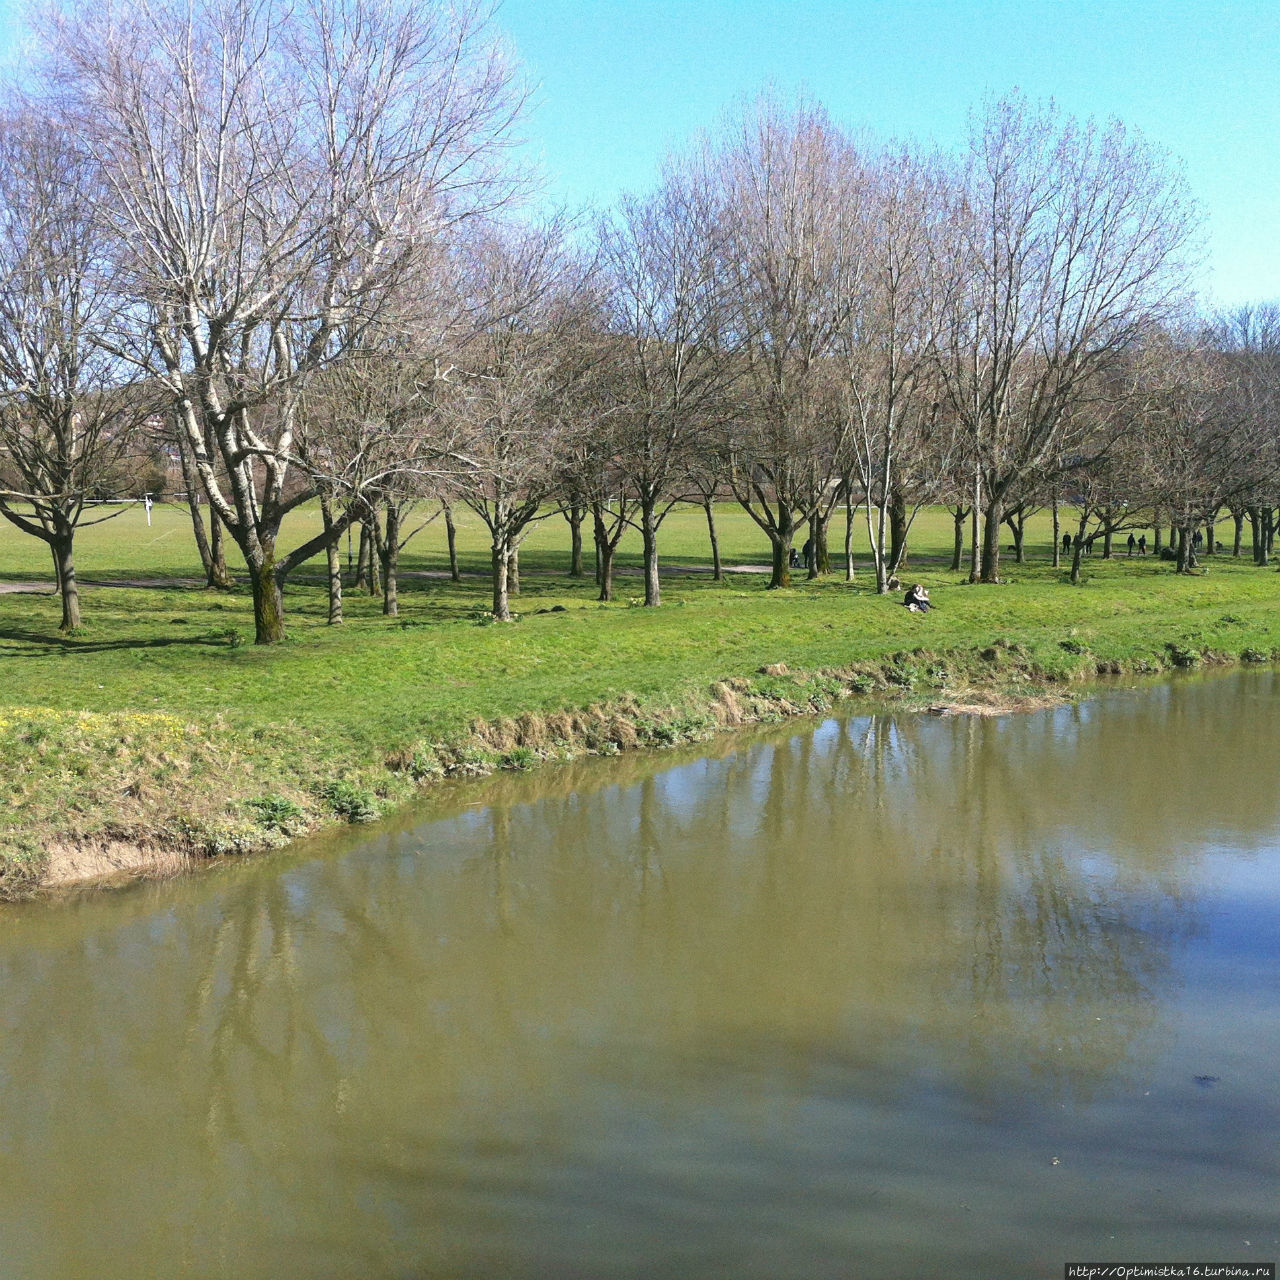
[705,97,859,588]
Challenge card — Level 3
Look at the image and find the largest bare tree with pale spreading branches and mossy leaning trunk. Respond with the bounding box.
[54,0,521,643]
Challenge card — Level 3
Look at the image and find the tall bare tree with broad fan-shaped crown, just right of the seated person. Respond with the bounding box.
[937,95,1193,582]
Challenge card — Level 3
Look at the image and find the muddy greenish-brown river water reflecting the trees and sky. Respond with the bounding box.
[0,673,1280,1280]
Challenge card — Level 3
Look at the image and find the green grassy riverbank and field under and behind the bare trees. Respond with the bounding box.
[0,508,1280,895]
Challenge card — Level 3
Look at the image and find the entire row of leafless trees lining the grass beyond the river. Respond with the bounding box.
[0,0,1280,643]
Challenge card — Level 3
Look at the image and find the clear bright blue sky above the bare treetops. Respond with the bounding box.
[0,0,1280,305]
